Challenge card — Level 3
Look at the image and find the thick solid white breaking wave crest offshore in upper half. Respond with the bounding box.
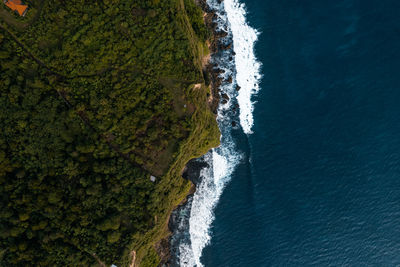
[224,0,261,134]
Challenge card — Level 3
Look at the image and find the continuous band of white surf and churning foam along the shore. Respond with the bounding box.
[167,0,261,267]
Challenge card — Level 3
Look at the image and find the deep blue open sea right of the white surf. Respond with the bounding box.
[202,0,400,267]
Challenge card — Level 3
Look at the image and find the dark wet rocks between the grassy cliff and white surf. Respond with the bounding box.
[156,0,240,267]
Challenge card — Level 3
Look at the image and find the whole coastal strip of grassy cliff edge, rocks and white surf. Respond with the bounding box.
[130,0,261,267]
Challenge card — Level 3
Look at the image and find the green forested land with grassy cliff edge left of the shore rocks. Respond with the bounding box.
[0,0,219,266]
